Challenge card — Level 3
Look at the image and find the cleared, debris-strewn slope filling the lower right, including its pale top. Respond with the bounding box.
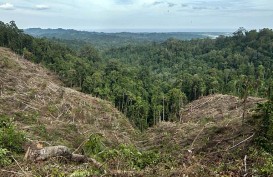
[139,94,265,176]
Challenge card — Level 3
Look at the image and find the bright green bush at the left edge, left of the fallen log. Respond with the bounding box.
[0,115,25,153]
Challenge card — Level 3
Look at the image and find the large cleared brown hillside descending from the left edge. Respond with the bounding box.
[0,48,138,176]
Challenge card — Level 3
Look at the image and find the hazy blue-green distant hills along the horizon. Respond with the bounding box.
[24,28,229,48]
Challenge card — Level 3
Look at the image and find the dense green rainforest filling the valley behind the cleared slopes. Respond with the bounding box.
[0,21,273,130]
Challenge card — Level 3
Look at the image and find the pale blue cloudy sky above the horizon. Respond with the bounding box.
[0,0,273,32]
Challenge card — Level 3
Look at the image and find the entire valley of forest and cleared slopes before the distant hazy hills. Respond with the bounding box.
[0,22,273,177]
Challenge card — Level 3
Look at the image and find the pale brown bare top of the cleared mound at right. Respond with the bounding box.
[181,94,265,122]
